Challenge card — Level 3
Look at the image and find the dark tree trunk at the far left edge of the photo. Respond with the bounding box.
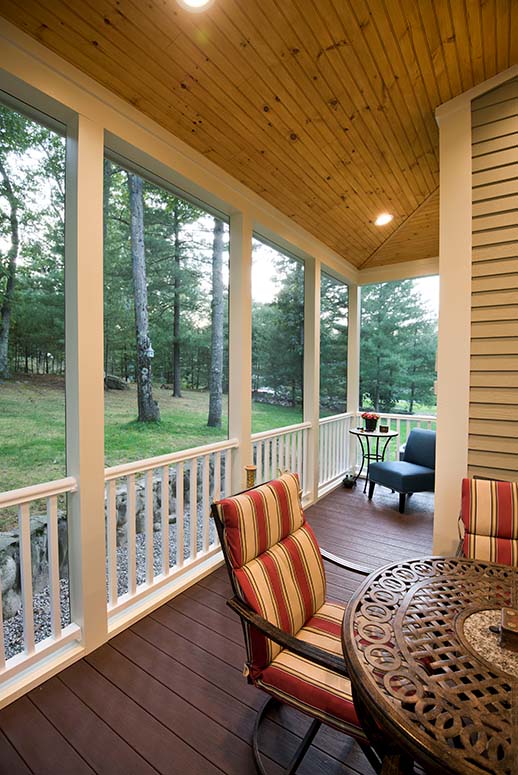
[0,160,20,377]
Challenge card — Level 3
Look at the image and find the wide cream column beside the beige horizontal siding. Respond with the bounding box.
[433,101,471,554]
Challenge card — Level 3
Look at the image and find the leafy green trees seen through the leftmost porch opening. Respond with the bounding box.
[0,107,64,376]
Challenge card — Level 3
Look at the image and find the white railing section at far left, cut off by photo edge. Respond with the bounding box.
[0,476,82,682]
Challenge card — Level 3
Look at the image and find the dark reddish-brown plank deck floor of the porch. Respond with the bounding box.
[0,488,433,775]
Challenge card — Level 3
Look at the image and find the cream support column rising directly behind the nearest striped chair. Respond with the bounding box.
[228,213,252,493]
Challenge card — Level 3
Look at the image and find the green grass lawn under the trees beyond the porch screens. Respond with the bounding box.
[0,375,301,492]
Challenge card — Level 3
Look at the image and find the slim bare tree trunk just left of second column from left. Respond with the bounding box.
[207,218,223,428]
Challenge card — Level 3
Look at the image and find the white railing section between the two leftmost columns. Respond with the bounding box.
[105,439,238,619]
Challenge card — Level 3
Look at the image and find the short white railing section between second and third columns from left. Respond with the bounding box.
[252,422,311,493]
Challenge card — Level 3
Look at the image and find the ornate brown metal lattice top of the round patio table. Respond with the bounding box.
[343,557,518,775]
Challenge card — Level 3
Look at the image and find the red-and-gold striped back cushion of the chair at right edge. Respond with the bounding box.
[461,479,518,566]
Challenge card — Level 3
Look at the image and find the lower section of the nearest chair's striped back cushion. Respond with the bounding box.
[234,523,326,678]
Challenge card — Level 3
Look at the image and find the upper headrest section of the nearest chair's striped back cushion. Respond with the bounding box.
[218,473,304,568]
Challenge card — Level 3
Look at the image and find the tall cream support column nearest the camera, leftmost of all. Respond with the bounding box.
[65,115,107,651]
